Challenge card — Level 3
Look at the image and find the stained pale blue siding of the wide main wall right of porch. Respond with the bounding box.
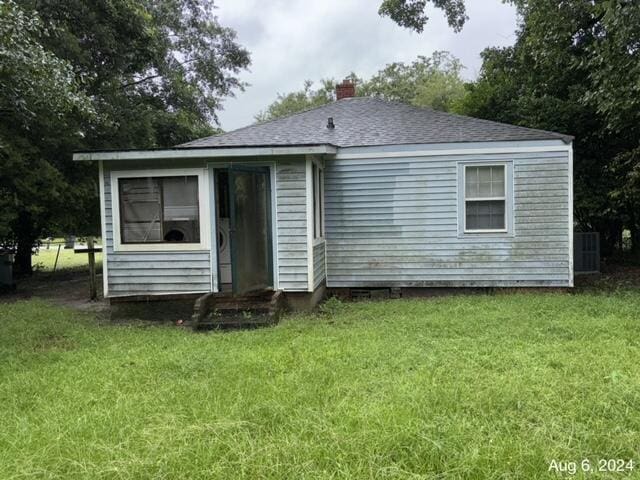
[325,151,570,287]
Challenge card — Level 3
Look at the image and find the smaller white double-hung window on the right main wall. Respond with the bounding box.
[464,165,507,232]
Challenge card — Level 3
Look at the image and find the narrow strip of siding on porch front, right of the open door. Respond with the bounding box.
[276,157,309,291]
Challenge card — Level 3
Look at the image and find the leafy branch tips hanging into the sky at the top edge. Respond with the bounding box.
[378,0,468,33]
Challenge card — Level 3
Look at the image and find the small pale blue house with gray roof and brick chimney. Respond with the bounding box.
[74,83,573,310]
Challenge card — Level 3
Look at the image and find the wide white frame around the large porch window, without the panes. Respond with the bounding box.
[111,167,211,252]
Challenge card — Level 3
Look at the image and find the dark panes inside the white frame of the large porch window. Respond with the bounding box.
[118,175,200,243]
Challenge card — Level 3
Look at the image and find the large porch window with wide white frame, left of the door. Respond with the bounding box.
[111,169,210,251]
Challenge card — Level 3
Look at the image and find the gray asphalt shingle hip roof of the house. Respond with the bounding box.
[178,97,573,148]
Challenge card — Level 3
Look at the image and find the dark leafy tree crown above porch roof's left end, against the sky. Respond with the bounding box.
[28,0,249,148]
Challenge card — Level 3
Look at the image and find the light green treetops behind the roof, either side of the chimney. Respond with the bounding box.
[255,52,466,122]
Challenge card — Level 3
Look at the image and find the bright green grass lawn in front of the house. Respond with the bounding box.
[0,291,640,479]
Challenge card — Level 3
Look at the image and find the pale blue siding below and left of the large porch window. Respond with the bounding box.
[104,162,211,297]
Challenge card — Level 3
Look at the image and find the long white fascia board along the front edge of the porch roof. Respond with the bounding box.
[73,145,337,162]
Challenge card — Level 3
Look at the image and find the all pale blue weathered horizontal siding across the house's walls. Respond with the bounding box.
[104,142,571,296]
